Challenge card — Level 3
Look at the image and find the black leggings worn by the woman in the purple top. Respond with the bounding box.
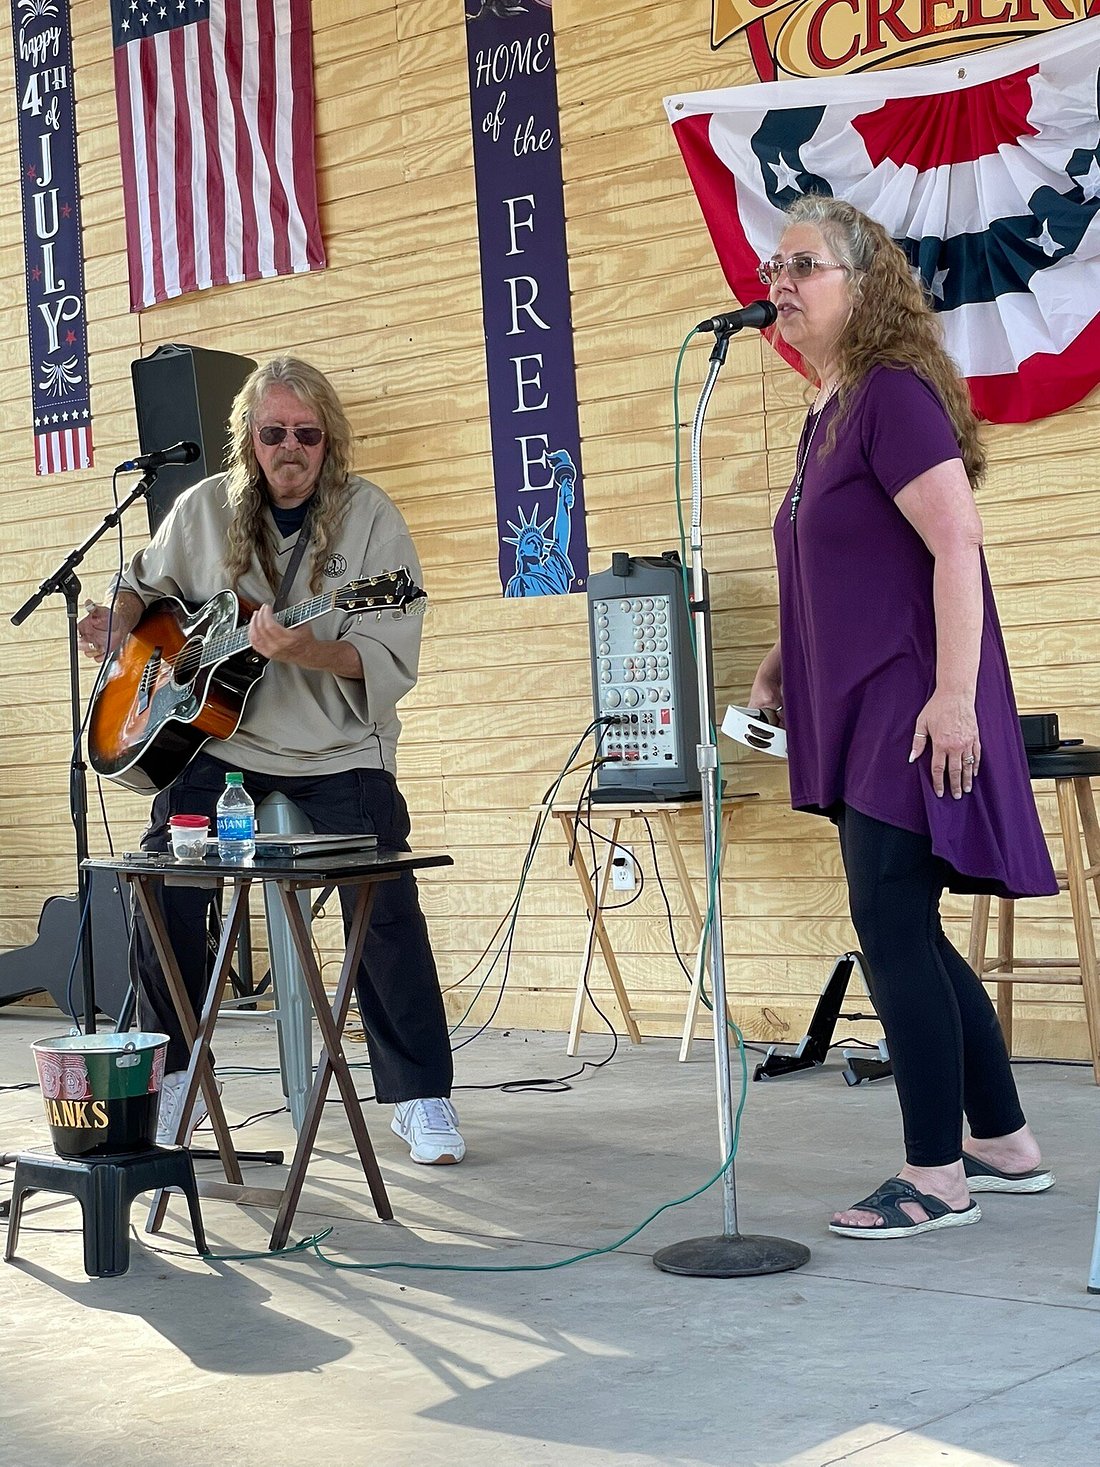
[832,795,1024,1166]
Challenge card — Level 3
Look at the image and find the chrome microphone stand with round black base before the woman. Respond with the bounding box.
[653,323,810,1278]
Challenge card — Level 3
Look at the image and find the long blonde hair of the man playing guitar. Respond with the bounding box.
[226,356,352,596]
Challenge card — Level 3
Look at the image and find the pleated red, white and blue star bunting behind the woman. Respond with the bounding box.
[666,19,1100,422]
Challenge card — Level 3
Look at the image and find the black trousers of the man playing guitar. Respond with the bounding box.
[132,751,453,1103]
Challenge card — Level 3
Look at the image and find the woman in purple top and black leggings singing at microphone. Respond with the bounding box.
[749,195,1057,1238]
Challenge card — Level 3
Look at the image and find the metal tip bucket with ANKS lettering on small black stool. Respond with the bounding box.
[31,1033,169,1157]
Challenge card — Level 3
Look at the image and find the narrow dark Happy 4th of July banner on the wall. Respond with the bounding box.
[12,0,92,474]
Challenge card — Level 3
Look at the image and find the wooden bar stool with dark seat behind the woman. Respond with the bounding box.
[967,745,1100,1084]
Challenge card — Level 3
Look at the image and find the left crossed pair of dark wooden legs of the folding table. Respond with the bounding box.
[133,876,249,1232]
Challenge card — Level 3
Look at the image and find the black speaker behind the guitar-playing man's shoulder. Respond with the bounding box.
[131,346,255,533]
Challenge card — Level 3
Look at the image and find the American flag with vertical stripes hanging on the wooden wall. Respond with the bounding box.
[111,0,324,311]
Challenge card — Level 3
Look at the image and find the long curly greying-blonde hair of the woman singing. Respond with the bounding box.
[786,194,986,489]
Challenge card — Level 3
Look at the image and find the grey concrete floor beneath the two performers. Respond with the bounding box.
[0,1009,1100,1467]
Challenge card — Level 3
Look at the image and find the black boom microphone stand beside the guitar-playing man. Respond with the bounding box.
[12,468,157,1034]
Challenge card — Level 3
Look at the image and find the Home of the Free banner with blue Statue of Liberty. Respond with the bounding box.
[465,0,588,596]
